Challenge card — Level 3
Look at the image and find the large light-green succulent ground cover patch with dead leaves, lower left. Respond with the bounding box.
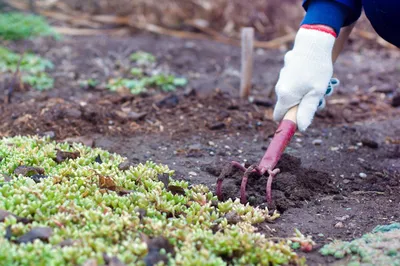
[0,137,304,265]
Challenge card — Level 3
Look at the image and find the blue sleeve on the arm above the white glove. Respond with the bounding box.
[302,0,362,35]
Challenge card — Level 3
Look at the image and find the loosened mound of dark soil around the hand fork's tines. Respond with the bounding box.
[219,154,339,213]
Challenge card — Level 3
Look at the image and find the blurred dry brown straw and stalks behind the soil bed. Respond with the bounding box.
[0,0,390,48]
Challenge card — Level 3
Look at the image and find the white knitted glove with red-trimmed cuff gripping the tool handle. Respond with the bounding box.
[274,28,336,131]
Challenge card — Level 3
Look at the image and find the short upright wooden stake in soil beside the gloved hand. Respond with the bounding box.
[240,28,254,98]
